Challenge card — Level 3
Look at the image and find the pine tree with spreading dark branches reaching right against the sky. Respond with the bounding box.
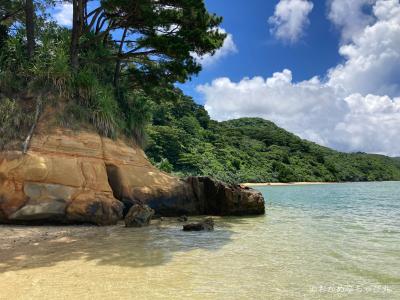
[71,0,226,85]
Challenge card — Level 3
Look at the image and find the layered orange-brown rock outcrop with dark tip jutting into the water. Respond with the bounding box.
[0,128,265,225]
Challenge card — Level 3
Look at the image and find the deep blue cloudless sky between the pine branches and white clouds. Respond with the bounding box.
[180,0,342,104]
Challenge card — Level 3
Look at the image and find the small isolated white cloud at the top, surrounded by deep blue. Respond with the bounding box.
[268,0,314,43]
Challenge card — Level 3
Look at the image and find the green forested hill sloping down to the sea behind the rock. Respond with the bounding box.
[146,96,400,182]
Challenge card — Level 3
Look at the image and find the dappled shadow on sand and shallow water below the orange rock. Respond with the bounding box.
[0,218,262,273]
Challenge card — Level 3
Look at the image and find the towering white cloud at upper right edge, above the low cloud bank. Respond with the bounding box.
[329,0,400,97]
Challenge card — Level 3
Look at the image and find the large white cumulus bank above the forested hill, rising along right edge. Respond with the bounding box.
[202,0,400,155]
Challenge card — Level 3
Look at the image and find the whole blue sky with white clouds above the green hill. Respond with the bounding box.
[55,0,400,156]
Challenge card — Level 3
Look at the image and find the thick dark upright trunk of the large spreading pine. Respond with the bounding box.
[70,0,84,71]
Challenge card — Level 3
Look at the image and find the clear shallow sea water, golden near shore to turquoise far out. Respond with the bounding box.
[0,182,400,299]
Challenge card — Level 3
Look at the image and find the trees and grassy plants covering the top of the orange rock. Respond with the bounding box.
[0,0,226,143]
